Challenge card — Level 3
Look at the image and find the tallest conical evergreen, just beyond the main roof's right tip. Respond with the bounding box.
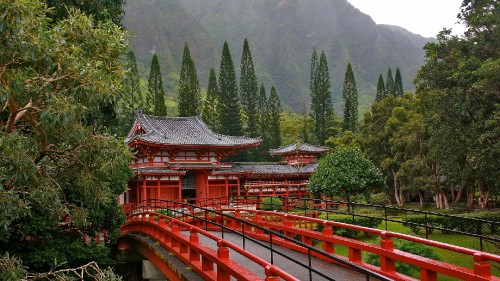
[240,38,259,137]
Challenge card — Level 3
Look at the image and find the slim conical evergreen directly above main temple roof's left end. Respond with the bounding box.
[146,54,167,116]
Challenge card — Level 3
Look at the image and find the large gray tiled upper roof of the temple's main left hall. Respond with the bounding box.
[125,113,261,147]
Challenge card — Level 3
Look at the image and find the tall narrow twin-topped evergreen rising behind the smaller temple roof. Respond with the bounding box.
[310,51,333,143]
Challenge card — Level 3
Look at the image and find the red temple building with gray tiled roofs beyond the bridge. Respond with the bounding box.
[120,113,328,203]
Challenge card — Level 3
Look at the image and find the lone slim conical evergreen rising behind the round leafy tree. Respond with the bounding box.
[342,63,358,132]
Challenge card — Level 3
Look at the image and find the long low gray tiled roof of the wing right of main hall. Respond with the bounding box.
[213,162,318,175]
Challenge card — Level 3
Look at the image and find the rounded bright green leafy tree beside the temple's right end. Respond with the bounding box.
[309,147,384,202]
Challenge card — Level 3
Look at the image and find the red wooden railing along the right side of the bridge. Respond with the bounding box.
[229,210,500,280]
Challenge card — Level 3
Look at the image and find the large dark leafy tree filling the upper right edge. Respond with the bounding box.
[415,0,500,208]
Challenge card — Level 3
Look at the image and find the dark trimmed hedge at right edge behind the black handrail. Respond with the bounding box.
[402,212,500,234]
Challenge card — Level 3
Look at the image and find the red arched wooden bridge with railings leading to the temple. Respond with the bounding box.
[118,200,500,281]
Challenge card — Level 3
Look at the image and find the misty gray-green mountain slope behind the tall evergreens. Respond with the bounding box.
[123,0,432,111]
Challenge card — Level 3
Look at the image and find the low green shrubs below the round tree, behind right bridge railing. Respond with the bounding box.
[317,213,382,238]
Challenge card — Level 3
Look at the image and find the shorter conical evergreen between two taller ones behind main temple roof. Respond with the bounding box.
[201,67,219,132]
